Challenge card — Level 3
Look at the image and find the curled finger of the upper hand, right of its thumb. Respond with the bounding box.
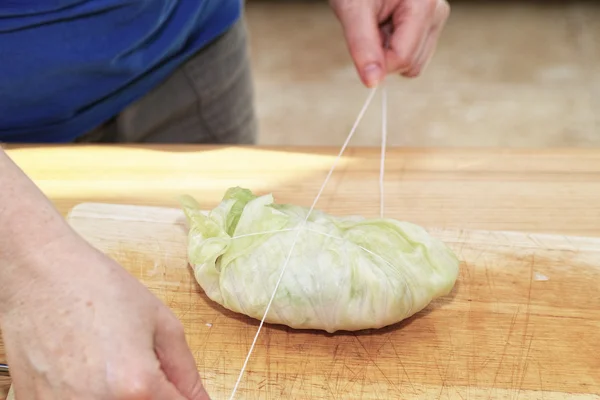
[386,0,438,74]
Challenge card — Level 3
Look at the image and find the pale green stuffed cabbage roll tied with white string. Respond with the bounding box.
[181,187,459,333]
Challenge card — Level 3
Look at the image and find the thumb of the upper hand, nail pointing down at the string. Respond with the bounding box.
[332,1,386,87]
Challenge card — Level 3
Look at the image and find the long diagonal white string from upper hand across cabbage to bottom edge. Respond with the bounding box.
[229,88,377,400]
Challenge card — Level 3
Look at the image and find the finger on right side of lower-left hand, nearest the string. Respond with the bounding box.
[155,316,210,400]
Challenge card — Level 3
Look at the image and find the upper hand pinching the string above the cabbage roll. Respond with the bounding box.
[330,0,450,87]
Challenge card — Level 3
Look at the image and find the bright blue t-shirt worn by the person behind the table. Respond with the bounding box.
[0,0,242,143]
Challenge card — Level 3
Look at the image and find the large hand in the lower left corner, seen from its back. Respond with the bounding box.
[0,231,209,400]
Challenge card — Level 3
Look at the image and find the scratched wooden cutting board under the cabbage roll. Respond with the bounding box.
[8,203,600,400]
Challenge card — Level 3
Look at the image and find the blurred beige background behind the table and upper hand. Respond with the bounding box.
[246,0,600,147]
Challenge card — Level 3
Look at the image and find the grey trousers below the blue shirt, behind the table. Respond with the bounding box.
[77,20,258,144]
